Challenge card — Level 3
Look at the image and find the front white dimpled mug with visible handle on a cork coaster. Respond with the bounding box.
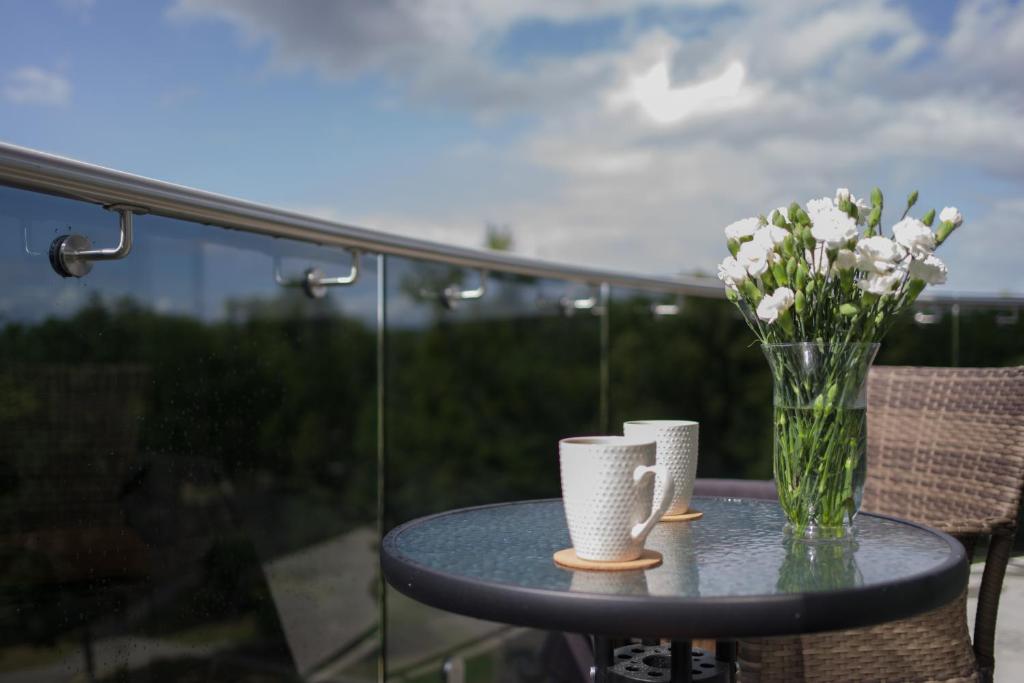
[558,436,673,562]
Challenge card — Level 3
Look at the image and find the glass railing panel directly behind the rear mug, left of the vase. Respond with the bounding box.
[608,288,771,479]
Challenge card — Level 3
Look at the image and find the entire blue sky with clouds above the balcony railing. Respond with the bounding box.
[0,0,1024,294]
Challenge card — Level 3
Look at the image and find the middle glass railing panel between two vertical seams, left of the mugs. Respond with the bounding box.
[385,258,600,682]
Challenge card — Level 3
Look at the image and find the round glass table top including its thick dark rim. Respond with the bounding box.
[381,498,968,638]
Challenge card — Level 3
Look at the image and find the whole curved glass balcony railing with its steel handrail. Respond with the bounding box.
[0,145,1024,683]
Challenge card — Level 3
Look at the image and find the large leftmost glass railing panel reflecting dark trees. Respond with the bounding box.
[0,188,379,682]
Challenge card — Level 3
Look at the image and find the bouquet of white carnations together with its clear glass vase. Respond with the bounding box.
[718,188,964,539]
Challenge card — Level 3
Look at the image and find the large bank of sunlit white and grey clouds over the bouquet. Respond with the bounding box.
[163,0,1024,289]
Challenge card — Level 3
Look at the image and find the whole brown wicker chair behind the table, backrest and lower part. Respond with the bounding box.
[739,367,1024,683]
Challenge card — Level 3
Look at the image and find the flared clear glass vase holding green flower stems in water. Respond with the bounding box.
[761,342,879,540]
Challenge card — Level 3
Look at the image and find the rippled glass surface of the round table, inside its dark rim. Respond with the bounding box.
[389,498,952,598]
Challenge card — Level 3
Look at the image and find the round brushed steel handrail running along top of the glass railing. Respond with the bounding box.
[0,142,1024,307]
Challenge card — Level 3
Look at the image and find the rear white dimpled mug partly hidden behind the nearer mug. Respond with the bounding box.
[623,420,699,515]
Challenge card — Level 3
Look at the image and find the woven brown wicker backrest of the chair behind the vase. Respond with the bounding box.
[863,366,1024,533]
